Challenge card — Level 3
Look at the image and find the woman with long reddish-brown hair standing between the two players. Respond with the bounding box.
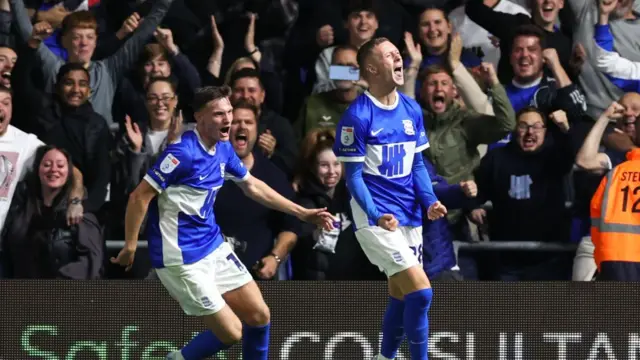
[292,129,384,280]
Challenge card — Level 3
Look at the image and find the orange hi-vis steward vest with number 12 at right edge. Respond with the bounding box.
[591,149,640,269]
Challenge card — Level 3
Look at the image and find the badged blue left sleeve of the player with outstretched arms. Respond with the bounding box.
[144,143,191,193]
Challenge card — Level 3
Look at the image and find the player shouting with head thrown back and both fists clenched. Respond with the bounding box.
[334,38,447,360]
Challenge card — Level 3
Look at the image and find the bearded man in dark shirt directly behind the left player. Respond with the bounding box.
[214,101,299,280]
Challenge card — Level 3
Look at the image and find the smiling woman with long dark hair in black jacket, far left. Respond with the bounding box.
[0,145,104,280]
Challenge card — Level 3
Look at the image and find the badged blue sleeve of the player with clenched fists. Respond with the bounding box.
[333,109,369,162]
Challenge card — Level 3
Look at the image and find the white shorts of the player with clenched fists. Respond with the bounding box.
[356,226,422,277]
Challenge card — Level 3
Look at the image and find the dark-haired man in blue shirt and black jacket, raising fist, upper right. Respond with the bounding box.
[490,25,586,148]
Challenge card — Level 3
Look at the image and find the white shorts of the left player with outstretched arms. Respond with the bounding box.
[156,242,253,316]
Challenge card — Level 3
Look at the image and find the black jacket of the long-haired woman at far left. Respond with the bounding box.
[0,181,104,280]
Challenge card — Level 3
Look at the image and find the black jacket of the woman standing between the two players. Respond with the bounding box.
[292,180,384,280]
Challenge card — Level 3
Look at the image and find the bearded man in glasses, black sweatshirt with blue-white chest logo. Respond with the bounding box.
[472,106,574,281]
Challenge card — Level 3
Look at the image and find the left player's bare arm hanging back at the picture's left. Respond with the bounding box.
[111,180,158,271]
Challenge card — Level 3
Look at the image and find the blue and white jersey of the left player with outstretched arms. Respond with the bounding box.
[144,130,249,268]
